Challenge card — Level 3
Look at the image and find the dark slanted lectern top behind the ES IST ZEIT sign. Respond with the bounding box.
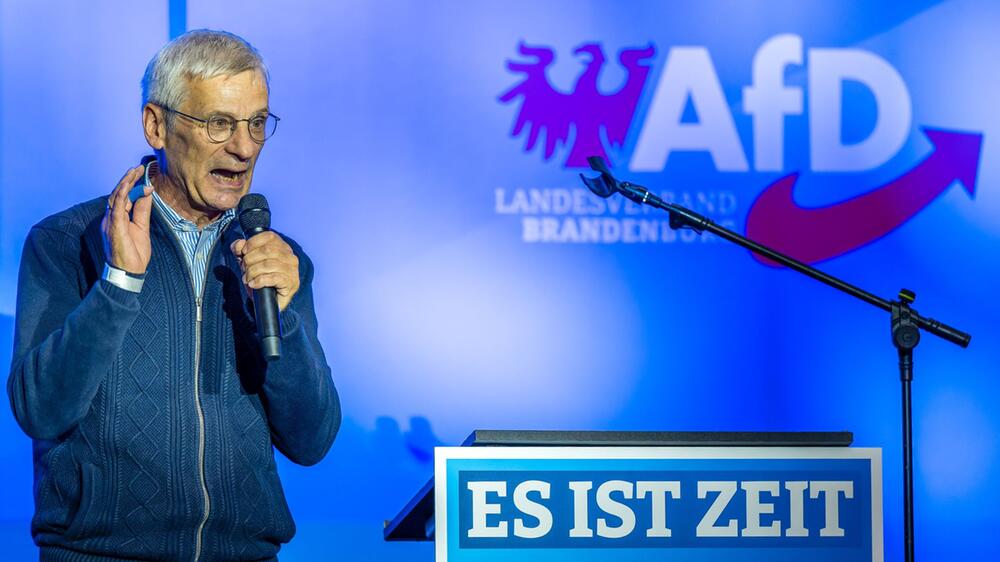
[383,429,854,541]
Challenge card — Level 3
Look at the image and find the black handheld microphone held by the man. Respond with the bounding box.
[237,193,281,361]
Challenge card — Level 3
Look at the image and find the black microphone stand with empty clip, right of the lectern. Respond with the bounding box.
[580,156,972,562]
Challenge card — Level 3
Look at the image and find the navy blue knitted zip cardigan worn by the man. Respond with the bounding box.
[7,197,341,561]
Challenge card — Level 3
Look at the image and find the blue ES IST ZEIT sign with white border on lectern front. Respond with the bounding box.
[434,447,883,562]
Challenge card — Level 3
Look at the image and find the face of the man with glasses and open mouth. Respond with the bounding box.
[163,70,268,217]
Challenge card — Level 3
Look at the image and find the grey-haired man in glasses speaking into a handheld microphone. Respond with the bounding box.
[8,31,340,561]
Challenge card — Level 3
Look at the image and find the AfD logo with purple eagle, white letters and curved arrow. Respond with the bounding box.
[499,34,982,263]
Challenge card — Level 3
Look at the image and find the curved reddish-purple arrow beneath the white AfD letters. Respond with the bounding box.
[746,129,983,266]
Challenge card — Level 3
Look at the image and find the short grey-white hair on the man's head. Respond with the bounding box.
[142,29,270,109]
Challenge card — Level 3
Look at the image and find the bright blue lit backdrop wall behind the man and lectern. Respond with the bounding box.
[0,0,1000,561]
